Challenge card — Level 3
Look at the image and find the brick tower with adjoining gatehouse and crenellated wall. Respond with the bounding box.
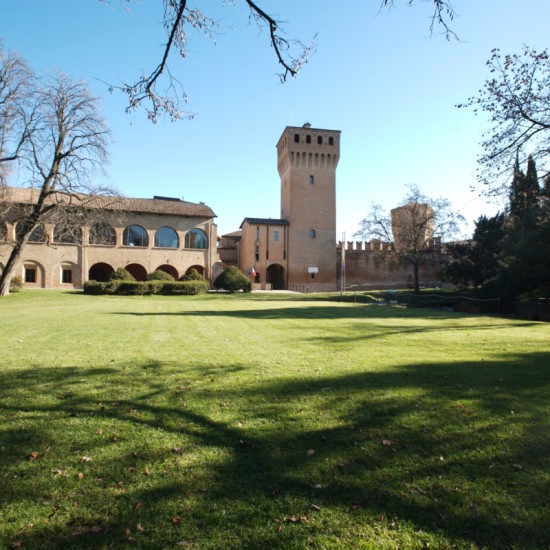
[218,124,441,292]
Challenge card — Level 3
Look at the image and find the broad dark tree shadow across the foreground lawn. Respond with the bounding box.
[0,353,550,548]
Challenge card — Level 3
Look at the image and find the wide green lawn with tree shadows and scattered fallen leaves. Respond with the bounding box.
[0,291,550,549]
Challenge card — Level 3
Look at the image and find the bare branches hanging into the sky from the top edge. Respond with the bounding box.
[105,0,456,122]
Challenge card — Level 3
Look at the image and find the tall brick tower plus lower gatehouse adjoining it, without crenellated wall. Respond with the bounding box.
[218,124,340,292]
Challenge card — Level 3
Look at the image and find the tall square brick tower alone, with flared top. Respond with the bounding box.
[277,124,340,291]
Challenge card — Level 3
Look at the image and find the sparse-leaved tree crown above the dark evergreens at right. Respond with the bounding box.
[458,46,550,196]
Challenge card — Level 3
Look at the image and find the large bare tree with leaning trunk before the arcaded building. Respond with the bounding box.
[0,47,112,295]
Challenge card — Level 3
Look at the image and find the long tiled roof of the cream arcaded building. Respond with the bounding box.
[3,187,216,218]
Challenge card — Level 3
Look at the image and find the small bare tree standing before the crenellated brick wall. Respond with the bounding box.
[354,185,464,292]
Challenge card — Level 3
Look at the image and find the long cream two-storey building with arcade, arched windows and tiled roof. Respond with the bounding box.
[0,188,220,289]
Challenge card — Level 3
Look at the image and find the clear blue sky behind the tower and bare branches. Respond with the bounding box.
[0,0,550,240]
